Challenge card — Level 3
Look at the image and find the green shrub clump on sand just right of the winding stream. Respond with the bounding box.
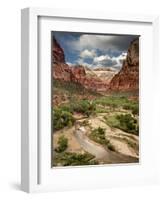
[89,127,115,151]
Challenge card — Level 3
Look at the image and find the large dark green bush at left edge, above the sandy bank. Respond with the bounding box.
[53,108,75,130]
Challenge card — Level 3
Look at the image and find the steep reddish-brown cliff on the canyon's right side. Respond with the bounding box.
[109,38,139,91]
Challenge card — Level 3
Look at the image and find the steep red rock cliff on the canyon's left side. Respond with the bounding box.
[52,38,109,91]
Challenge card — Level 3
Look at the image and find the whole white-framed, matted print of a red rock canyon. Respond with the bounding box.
[21,8,159,192]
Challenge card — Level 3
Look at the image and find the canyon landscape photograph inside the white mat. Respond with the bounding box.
[50,31,141,167]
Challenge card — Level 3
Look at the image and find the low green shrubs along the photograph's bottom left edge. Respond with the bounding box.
[53,152,98,166]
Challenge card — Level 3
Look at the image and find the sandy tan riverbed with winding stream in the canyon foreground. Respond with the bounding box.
[53,101,139,166]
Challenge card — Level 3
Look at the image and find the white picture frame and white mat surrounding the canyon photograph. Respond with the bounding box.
[21,8,159,192]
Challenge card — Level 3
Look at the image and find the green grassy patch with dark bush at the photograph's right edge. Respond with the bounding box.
[104,114,139,135]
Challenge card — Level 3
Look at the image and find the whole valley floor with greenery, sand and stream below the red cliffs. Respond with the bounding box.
[52,80,139,167]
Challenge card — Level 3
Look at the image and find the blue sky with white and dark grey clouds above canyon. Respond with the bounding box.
[53,32,138,69]
